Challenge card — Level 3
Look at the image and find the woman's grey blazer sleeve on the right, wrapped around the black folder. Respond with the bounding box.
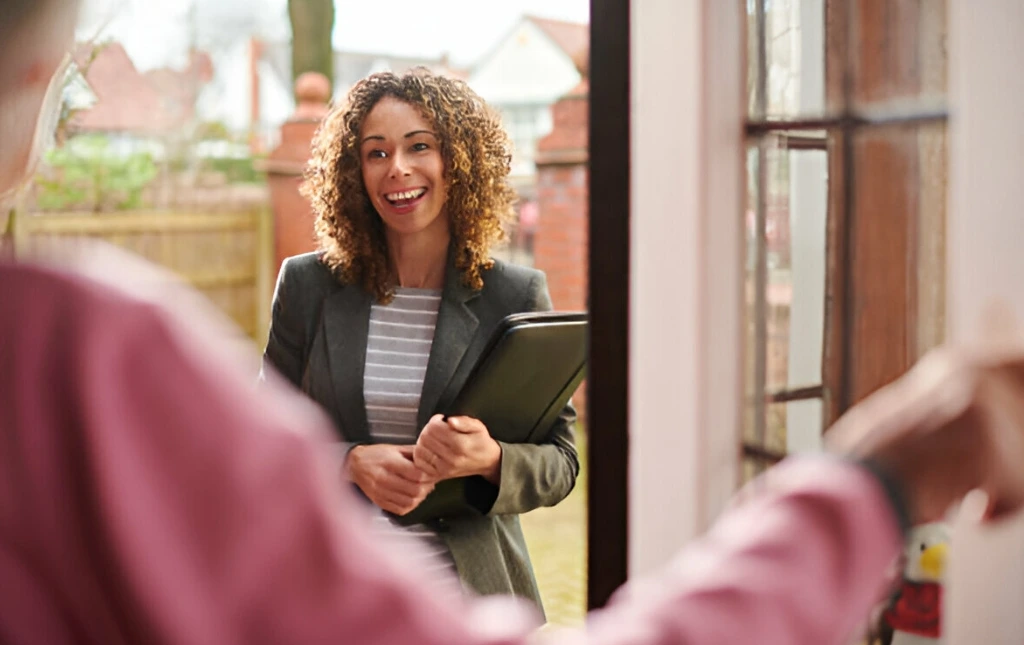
[490,273,580,515]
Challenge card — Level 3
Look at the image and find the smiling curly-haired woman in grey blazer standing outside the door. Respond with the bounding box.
[264,71,580,618]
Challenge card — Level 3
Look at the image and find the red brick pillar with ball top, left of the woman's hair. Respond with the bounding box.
[263,72,331,275]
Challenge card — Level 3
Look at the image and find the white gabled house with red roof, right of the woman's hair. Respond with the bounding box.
[467,15,590,203]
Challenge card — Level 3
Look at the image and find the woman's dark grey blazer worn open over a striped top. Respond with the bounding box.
[263,253,580,607]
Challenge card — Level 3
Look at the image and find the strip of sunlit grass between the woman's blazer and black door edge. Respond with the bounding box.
[521,428,587,626]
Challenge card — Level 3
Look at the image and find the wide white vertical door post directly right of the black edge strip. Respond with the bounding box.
[629,0,745,576]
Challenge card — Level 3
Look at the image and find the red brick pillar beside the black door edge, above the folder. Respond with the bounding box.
[534,80,589,417]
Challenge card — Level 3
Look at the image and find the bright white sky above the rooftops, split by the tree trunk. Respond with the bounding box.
[79,0,590,70]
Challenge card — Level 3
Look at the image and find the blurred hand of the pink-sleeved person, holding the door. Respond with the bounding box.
[826,344,1024,524]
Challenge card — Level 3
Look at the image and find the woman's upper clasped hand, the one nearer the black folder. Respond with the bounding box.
[413,415,502,484]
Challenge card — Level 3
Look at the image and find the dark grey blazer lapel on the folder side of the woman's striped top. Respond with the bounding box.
[417,263,479,428]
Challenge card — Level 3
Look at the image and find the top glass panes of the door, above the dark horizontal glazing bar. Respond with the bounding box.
[746,0,948,120]
